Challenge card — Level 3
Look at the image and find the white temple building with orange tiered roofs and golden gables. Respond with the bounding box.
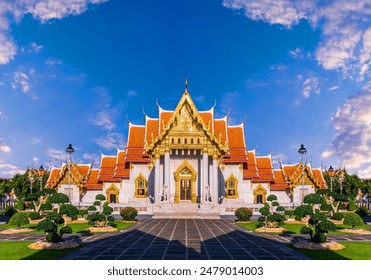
[47,86,327,217]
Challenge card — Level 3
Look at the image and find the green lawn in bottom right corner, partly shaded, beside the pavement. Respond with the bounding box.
[291,242,371,260]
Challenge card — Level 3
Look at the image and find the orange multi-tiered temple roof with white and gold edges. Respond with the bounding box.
[47,89,326,191]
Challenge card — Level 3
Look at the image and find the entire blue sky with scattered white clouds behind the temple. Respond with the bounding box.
[0,0,371,178]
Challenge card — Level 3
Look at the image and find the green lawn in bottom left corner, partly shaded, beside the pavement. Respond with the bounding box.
[0,241,78,260]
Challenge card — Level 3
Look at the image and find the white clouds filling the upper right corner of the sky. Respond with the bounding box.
[223,0,371,80]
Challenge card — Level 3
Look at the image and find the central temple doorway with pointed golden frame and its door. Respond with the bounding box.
[174,160,197,203]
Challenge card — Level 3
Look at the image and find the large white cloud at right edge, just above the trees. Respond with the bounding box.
[322,92,371,177]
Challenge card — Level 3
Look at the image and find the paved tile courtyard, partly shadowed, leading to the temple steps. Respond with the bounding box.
[65,219,306,260]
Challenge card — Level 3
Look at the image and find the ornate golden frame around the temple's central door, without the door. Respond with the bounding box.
[174,160,197,203]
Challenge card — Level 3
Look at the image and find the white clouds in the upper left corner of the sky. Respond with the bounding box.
[0,0,108,64]
